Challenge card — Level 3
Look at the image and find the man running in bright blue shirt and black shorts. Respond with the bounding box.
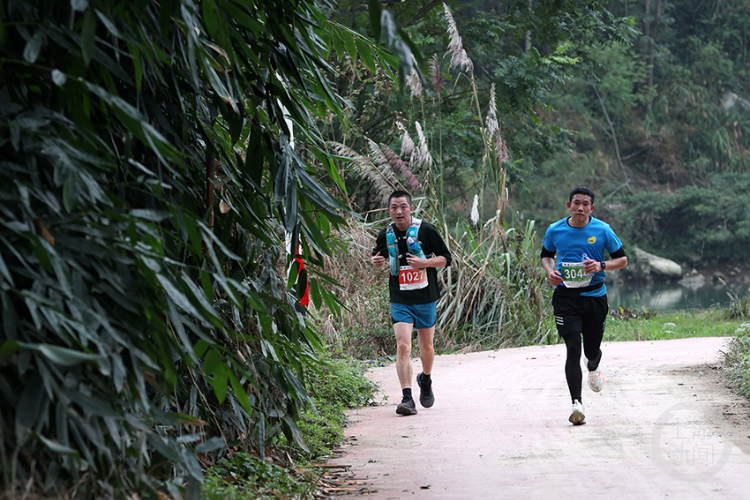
[541,186,628,425]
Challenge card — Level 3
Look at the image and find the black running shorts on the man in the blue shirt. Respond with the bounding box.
[552,289,609,337]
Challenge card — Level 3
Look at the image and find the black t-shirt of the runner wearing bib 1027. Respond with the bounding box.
[372,221,453,305]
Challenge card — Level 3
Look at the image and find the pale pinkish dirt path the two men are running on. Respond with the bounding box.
[332,338,750,500]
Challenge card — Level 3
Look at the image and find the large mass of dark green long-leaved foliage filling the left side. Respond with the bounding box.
[0,0,366,498]
